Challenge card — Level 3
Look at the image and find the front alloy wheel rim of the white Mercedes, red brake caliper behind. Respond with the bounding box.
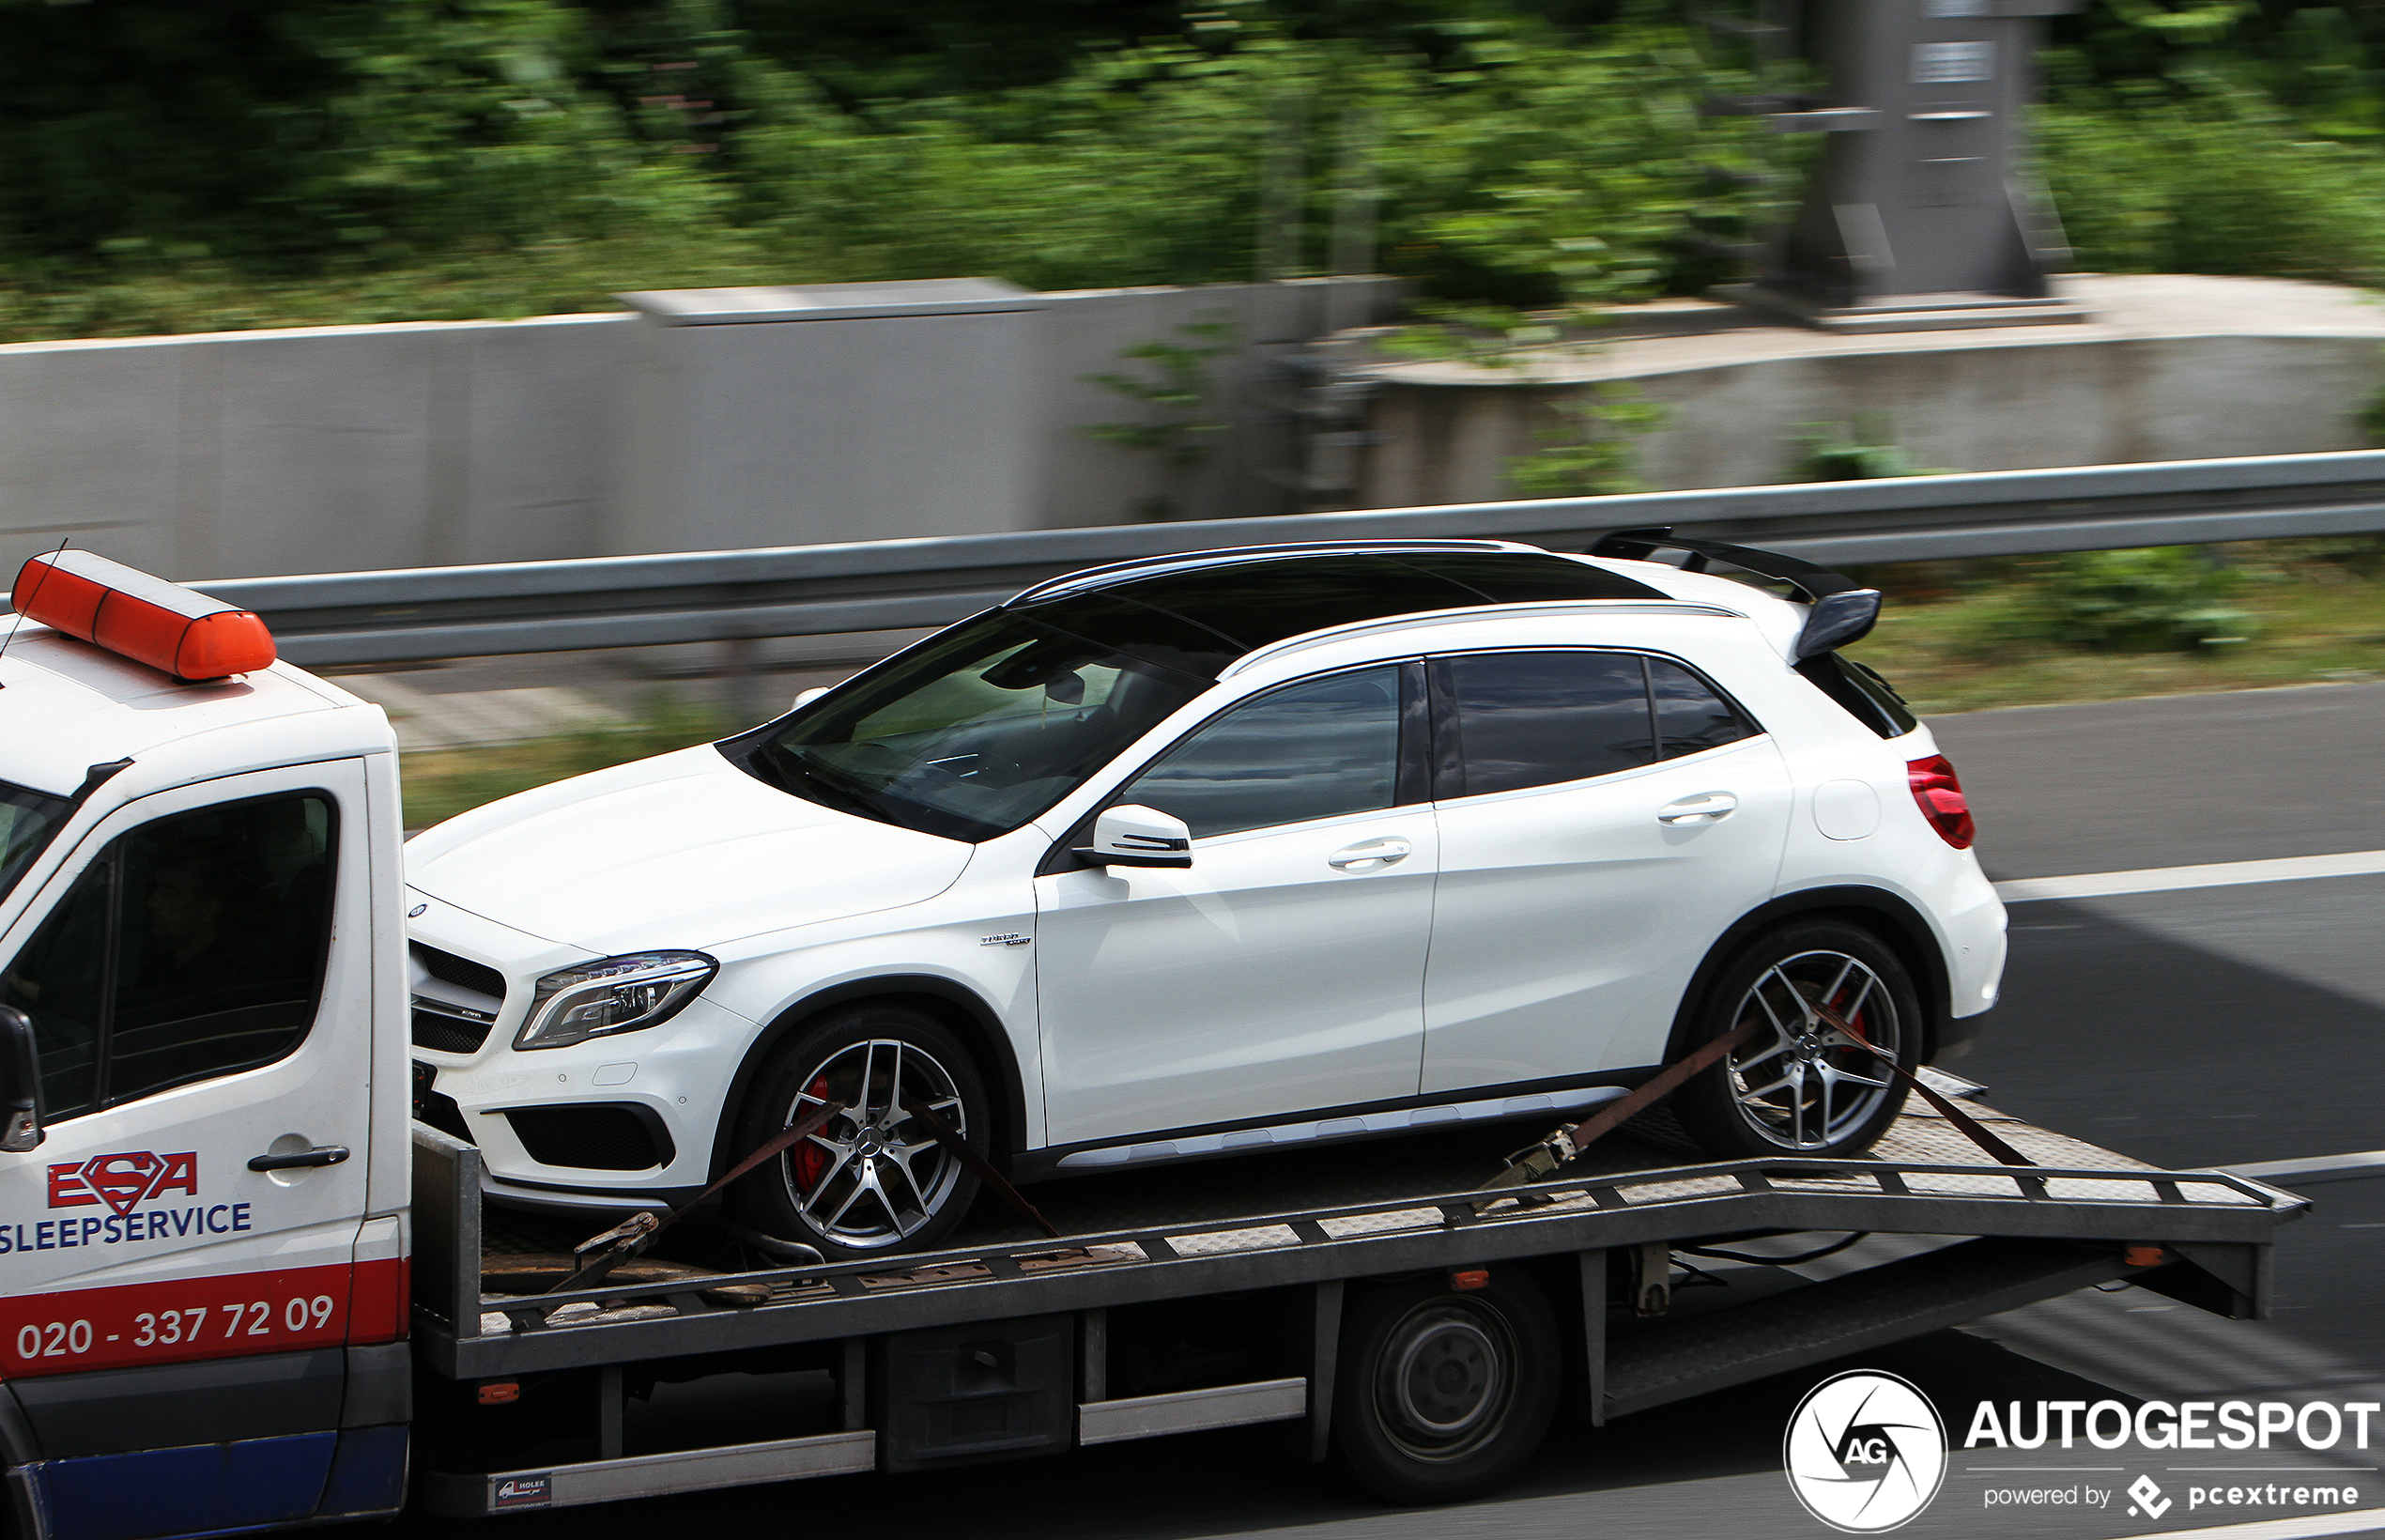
[777,1037,968,1252]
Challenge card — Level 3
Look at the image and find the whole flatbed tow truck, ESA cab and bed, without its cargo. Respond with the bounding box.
[0,562,2304,1540]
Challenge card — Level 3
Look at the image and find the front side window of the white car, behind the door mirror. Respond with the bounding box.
[1118,668,1400,837]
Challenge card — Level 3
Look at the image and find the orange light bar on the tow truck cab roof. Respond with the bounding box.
[9,550,274,680]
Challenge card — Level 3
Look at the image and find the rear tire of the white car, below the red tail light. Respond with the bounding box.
[1672,920,1922,1161]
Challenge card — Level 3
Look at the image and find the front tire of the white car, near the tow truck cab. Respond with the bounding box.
[730,1004,992,1258]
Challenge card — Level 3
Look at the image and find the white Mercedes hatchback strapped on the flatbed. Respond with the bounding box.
[408,531,2004,1254]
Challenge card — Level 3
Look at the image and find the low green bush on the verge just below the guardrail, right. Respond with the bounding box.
[1968,546,2258,654]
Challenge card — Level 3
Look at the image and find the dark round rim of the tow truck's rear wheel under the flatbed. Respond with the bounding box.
[1374,1300,1516,1461]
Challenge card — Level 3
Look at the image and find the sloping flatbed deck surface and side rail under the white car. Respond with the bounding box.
[415,1086,2304,1378]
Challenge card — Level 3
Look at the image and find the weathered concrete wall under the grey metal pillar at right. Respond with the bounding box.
[1364,274,2385,508]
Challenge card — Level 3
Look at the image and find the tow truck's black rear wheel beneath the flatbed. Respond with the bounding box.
[1333,1269,1562,1504]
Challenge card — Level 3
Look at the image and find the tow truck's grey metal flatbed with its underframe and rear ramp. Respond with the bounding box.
[412,1106,2306,1514]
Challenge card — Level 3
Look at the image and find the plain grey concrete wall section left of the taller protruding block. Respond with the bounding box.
[0,317,627,589]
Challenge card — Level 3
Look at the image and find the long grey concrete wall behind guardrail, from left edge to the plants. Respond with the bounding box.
[0,279,1397,587]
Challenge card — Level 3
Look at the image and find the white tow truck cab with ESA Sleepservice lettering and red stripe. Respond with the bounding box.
[0,558,412,1540]
